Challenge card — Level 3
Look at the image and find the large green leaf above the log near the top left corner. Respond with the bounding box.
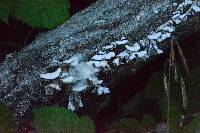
[12,0,69,29]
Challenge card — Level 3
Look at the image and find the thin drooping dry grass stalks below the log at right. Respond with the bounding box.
[163,38,190,133]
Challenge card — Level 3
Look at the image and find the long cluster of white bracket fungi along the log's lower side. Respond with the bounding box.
[40,0,200,111]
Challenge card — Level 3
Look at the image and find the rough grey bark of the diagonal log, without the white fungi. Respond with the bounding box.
[0,0,200,116]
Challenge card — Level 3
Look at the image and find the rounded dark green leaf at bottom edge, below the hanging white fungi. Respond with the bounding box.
[33,107,95,133]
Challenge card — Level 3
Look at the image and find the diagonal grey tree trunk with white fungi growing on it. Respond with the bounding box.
[0,0,200,117]
